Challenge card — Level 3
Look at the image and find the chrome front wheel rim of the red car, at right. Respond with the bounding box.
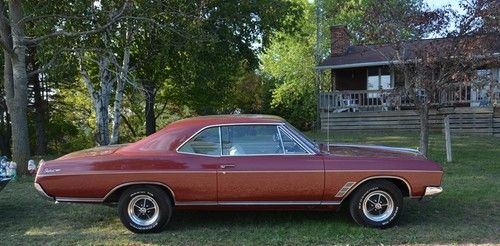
[363,190,394,222]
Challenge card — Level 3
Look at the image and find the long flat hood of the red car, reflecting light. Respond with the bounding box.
[323,144,426,160]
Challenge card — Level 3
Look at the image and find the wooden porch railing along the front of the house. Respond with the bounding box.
[319,86,500,112]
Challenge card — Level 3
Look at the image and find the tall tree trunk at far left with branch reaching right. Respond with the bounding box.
[0,0,128,174]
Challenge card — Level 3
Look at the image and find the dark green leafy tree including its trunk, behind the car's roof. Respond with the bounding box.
[132,0,303,129]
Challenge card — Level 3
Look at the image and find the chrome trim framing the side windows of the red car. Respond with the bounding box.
[175,122,316,157]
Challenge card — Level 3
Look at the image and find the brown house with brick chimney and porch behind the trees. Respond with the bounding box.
[316,26,500,136]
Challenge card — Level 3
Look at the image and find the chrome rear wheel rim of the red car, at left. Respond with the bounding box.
[128,195,160,226]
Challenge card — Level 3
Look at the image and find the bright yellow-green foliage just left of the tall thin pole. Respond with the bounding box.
[261,1,316,129]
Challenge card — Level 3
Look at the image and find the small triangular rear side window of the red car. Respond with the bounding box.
[179,127,220,155]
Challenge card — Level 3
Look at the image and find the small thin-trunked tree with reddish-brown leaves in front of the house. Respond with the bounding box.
[364,0,500,155]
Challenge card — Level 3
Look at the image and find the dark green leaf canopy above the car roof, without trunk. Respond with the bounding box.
[167,1,303,114]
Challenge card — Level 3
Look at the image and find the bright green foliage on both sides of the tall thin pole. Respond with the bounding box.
[260,0,422,129]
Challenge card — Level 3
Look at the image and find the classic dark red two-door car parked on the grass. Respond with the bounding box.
[35,115,443,233]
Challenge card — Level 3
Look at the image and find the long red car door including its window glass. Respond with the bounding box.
[217,124,324,205]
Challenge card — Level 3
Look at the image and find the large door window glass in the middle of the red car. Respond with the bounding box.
[221,125,283,155]
